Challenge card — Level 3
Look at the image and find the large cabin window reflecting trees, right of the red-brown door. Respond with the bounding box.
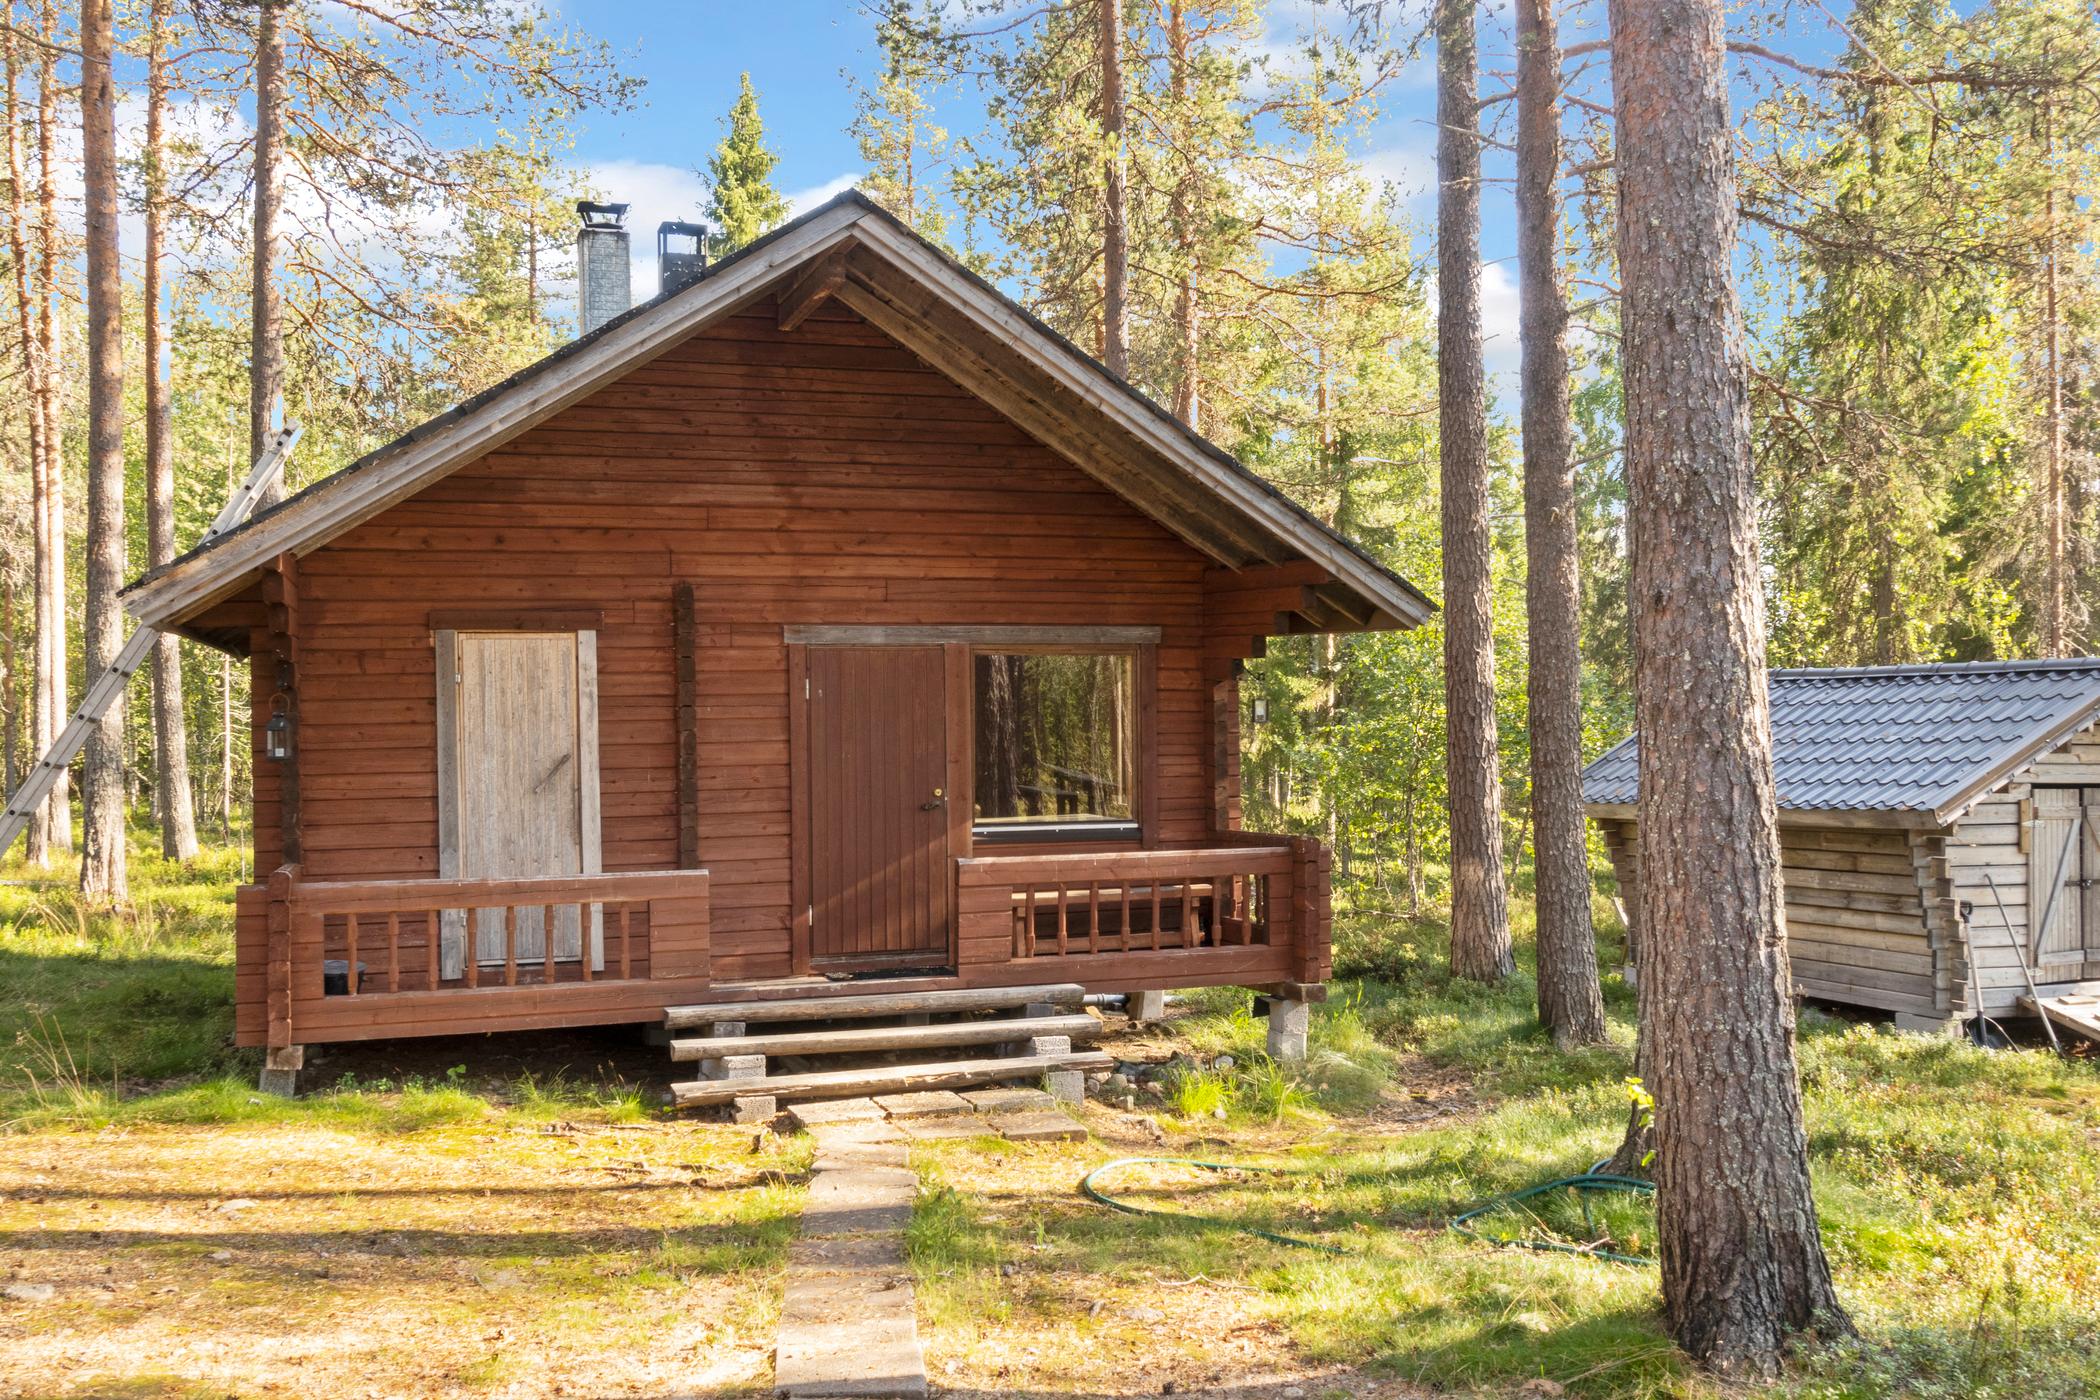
[972,649,1138,842]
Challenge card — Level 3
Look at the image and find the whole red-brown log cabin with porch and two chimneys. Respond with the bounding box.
[126,191,1430,1102]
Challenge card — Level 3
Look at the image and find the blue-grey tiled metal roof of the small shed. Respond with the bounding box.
[1581,659,2100,823]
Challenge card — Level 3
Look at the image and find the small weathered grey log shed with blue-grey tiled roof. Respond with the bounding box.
[1583,659,2100,1031]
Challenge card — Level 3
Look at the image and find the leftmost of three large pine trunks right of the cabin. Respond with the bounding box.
[1436,0,1516,982]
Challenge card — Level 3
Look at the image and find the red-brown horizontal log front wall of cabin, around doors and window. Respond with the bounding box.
[256,302,1214,978]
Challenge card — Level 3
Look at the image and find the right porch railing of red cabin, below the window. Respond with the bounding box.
[956,833,1327,984]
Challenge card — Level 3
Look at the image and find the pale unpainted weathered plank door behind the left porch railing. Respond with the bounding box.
[439,632,603,976]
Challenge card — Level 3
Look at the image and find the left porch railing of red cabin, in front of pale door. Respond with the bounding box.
[251,867,708,1045]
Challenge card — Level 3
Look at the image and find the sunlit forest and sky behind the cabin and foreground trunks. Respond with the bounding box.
[0,0,2100,928]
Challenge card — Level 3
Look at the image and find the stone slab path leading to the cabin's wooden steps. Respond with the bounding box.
[773,1089,1086,1400]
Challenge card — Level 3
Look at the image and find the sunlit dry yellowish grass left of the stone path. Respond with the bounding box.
[0,1115,806,1396]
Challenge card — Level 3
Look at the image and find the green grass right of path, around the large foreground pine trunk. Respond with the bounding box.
[914,902,2100,1400]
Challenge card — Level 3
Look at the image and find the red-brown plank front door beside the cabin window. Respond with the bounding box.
[802,646,951,970]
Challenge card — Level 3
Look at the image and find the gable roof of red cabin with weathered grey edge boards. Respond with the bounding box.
[124,191,1434,630]
